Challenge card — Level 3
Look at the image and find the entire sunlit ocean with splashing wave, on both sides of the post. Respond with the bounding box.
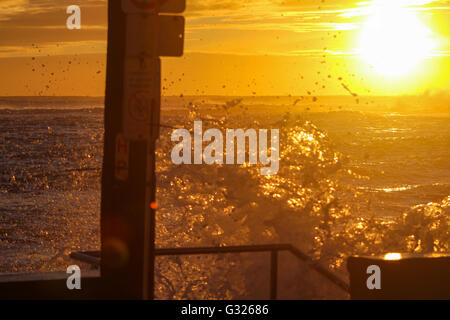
[0,97,450,298]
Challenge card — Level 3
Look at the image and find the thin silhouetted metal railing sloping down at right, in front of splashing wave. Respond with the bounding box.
[70,244,349,300]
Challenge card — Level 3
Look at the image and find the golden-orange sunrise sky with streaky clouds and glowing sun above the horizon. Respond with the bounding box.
[0,0,450,96]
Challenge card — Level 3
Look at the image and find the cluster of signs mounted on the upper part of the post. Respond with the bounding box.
[122,0,185,140]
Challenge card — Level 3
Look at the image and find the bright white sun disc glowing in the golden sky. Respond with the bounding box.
[358,0,435,77]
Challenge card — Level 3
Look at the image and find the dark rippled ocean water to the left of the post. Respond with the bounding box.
[0,101,103,273]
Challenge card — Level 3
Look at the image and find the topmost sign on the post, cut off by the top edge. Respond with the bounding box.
[122,0,186,14]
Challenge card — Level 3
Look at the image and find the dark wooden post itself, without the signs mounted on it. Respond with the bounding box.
[101,0,160,299]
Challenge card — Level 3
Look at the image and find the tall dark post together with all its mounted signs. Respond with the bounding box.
[101,0,185,299]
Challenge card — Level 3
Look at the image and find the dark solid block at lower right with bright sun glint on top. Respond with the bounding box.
[347,253,450,300]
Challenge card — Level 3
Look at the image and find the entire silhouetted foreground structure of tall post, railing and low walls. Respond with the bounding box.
[0,0,450,300]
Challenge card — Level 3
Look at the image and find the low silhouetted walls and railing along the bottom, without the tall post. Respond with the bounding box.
[0,249,450,300]
